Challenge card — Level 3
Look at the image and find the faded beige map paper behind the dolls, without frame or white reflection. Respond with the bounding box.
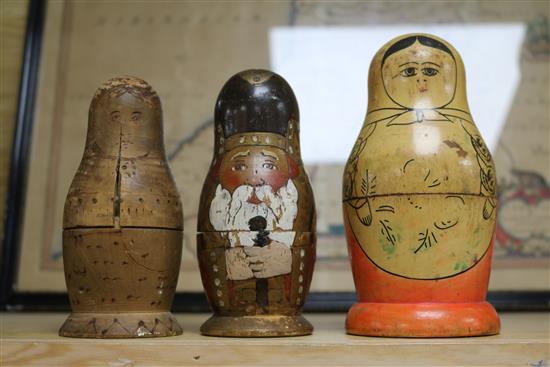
[17,1,550,291]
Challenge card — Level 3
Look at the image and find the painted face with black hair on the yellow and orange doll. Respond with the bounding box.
[382,40,456,109]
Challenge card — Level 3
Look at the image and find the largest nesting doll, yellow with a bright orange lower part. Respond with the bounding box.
[343,34,500,337]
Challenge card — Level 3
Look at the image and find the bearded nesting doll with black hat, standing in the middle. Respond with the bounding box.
[201,70,316,337]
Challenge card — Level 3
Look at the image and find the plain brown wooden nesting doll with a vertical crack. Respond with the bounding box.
[59,77,183,338]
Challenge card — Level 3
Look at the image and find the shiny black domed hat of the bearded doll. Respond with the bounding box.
[215,69,299,138]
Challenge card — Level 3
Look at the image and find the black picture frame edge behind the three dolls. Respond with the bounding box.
[0,0,550,312]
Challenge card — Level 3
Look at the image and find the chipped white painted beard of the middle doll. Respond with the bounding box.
[209,179,298,247]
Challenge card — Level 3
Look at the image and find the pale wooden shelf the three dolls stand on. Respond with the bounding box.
[0,312,550,367]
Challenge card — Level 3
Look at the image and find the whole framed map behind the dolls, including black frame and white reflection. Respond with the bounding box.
[2,0,550,310]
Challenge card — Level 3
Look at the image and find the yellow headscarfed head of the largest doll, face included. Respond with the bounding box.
[368,33,469,116]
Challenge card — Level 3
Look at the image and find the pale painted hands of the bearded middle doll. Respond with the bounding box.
[244,241,292,278]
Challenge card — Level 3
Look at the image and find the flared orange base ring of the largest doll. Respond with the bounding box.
[346,302,500,338]
